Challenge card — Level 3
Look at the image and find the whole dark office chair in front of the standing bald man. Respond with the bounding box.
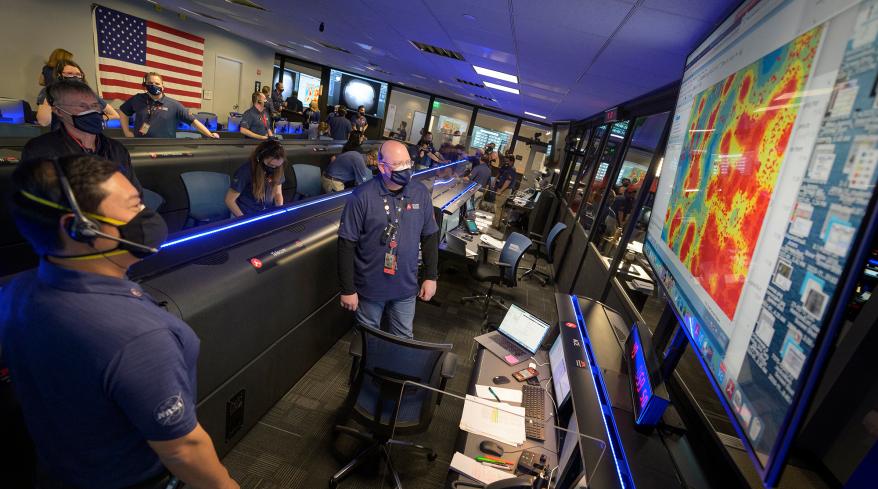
[329,325,457,489]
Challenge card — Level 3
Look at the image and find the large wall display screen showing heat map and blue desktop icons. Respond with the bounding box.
[645,0,878,484]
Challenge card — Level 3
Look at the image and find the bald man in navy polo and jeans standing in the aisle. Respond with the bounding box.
[338,141,439,338]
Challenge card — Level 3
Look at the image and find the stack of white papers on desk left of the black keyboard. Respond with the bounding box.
[460,394,525,446]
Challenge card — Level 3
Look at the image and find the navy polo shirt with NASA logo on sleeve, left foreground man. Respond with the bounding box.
[0,261,199,489]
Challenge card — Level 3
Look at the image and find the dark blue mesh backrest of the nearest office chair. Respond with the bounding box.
[351,325,453,434]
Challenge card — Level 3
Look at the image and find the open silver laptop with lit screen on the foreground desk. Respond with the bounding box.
[473,304,549,365]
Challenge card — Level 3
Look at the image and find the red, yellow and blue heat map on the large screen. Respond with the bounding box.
[662,27,821,319]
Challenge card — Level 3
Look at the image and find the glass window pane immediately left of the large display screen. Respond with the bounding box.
[598,112,668,318]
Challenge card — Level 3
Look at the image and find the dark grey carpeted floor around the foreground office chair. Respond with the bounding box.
[223,248,557,489]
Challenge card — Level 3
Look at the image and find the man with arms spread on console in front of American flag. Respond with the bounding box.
[119,72,219,139]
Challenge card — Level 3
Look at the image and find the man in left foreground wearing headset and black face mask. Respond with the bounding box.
[0,156,238,489]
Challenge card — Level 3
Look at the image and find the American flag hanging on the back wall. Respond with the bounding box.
[94,6,204,109]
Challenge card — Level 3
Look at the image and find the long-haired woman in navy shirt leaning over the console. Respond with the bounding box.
[226,139,286,217]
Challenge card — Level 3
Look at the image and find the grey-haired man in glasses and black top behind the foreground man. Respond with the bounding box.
[21,80,143,193]
